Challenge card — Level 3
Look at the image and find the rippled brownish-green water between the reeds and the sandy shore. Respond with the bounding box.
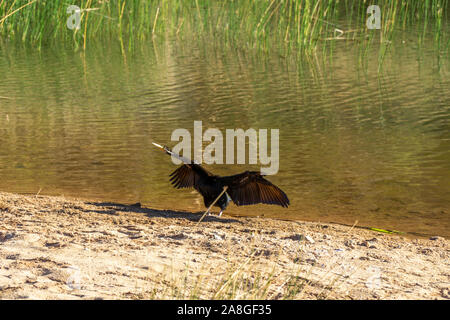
[0,37,450,237]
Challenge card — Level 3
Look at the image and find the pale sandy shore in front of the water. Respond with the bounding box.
[0,192,450,299]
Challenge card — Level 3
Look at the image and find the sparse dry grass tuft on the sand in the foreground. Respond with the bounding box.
[142,251,356,300]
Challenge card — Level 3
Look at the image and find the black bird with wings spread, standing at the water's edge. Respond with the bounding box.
[153,143,289,216]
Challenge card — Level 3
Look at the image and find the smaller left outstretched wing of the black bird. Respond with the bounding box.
[170,163,212,189]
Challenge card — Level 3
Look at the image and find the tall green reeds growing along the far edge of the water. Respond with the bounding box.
[0,0,449,53]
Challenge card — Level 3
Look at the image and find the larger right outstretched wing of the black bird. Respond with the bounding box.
[221,171,289,208]
